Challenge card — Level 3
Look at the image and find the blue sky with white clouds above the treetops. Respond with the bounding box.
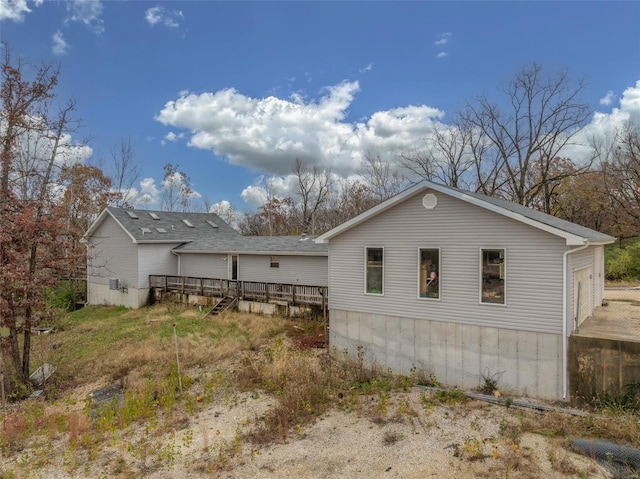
[0,0,640,211]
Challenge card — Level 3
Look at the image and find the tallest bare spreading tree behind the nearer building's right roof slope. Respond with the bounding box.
[460,64,592,206]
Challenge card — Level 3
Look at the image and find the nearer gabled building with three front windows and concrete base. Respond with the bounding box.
[316,182,614,399]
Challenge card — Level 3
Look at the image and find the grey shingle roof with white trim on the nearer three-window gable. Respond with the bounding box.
[316,181,615,245]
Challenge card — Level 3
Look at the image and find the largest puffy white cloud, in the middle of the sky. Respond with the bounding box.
[156,81,443,178]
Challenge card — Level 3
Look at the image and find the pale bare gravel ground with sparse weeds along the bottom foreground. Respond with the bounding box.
[7,388,610,479]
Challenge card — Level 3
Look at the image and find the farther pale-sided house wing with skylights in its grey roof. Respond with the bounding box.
[83,207,328,308]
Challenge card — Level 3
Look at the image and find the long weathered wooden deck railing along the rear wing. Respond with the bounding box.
[149,274,328,306]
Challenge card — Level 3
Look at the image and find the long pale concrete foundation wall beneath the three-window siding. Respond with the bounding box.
[329,310,562,399]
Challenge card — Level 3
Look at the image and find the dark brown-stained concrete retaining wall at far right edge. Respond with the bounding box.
[569,336,640,404]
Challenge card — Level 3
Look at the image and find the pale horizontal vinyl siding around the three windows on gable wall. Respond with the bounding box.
[329,192,567,333]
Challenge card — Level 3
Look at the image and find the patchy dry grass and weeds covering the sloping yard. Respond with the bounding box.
[0,306,640,477]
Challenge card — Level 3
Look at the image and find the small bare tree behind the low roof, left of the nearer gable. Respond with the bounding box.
[294,159,331,234]
